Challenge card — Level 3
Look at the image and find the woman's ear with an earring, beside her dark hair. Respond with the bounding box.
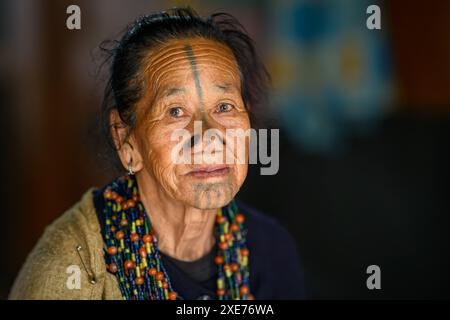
[109,110,143,172]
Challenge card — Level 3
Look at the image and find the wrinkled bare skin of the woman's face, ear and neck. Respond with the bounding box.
[111,38,250,260]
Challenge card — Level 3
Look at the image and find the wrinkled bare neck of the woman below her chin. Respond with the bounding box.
[136,172,216,261]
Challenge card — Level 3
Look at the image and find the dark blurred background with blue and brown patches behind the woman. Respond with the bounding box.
[0,0,450,299]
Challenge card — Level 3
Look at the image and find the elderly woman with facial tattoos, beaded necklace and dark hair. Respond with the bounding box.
[10,9,304,300]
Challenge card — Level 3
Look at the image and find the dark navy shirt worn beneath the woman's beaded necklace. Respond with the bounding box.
[94,190,305,300]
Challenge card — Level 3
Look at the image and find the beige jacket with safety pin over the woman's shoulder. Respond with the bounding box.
[9,189,123,299]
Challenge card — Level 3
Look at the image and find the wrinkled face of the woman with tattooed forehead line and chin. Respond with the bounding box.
[134,38,250,209]
